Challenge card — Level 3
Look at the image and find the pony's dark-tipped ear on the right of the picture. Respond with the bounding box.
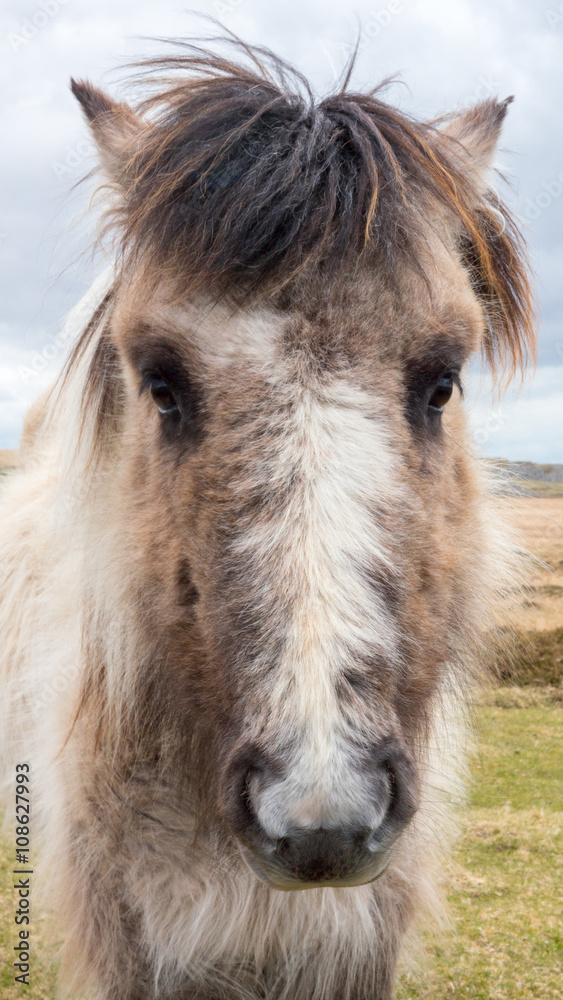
[442,97,514,188]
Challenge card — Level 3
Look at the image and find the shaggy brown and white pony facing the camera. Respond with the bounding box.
[0,41,534,1000]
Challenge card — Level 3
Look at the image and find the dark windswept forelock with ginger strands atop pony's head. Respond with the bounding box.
[68,38,534,384]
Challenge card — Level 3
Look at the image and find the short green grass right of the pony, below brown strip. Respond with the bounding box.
[397,689,563,1000]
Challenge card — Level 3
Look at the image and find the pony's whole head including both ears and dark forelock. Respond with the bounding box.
[70,48,530,889]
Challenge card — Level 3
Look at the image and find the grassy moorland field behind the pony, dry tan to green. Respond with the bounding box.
[0,496,563,1000]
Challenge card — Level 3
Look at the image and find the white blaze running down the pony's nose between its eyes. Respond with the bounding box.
[234,381,400,837]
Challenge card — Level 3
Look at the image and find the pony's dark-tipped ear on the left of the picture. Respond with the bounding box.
[70,79,145,187]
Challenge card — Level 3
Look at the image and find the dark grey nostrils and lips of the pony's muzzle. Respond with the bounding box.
[222,744,418,891]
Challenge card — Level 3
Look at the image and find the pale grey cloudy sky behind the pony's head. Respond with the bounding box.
[0,0,563,462]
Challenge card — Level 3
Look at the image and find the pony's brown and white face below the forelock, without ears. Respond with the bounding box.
[104,250,484,889]
